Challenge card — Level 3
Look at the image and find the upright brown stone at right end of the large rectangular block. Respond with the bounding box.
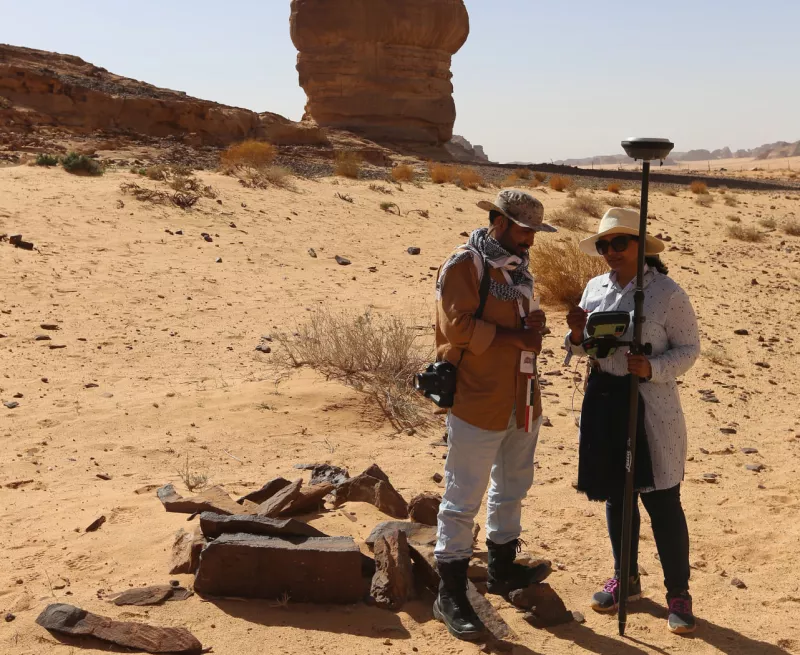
[370,530,414,610]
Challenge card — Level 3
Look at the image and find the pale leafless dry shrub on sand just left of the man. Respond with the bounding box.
[272,309,433,429]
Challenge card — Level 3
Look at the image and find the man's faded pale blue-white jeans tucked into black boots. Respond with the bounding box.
[434,412,542,562]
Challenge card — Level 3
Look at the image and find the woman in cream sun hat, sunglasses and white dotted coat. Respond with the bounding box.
[566,208,700,634]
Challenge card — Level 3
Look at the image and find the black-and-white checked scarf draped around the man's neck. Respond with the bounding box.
[436,227,533,300]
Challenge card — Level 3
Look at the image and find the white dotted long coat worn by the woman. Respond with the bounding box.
[565,268,700,489]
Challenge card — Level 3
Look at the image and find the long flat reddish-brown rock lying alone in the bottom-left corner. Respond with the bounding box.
[36,603,203,653]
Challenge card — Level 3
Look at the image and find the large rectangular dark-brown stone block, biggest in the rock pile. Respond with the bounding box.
[194,534,364,603]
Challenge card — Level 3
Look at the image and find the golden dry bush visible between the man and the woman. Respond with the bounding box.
[531,239,608,308]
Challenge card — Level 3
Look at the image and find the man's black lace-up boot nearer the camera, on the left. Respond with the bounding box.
[433,559,487,641]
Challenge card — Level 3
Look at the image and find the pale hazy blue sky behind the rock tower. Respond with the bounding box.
[0,0,800,162]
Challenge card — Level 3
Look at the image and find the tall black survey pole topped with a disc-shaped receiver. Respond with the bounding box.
[618,139,673,635]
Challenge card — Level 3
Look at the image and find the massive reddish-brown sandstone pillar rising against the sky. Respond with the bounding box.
[291,0,469,144]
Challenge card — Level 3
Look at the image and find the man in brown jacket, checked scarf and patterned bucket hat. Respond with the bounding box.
[433,189,556,640]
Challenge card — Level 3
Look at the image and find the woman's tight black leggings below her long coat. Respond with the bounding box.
[606,485,689,595]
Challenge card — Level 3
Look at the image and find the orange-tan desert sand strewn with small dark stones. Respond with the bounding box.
[0,160,800,655]
